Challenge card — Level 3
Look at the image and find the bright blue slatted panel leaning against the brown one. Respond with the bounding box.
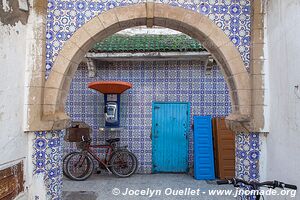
[194,116,215,180]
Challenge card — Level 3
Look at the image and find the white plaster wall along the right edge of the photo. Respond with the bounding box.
[266,0,300,199]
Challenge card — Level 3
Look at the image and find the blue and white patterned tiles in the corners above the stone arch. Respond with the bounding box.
[46,0,251,75]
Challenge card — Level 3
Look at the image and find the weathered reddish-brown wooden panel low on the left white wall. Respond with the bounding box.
[0,162,24,200]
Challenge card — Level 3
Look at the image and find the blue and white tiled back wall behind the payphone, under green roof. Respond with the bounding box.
[65,61,231,173]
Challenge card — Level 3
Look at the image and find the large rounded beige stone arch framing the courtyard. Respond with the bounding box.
[40,3,252,131]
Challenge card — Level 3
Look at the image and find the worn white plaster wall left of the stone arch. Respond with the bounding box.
[0,22,27,168]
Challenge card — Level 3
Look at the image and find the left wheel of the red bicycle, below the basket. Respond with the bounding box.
[66,152,94,181]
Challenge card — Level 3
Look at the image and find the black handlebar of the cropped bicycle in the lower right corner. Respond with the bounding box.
[217,178,297,190]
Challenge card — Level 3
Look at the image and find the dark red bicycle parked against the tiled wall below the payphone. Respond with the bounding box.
[63,131,138,181]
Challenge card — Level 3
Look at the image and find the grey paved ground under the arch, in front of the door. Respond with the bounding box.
[63,174,235,200]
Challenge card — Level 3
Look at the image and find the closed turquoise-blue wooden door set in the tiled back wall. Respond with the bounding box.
[152,102,190,173]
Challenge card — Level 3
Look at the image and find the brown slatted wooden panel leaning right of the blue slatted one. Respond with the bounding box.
[213,118,235,179]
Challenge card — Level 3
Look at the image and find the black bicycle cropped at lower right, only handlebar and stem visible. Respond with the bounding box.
[217,178,297,200]
